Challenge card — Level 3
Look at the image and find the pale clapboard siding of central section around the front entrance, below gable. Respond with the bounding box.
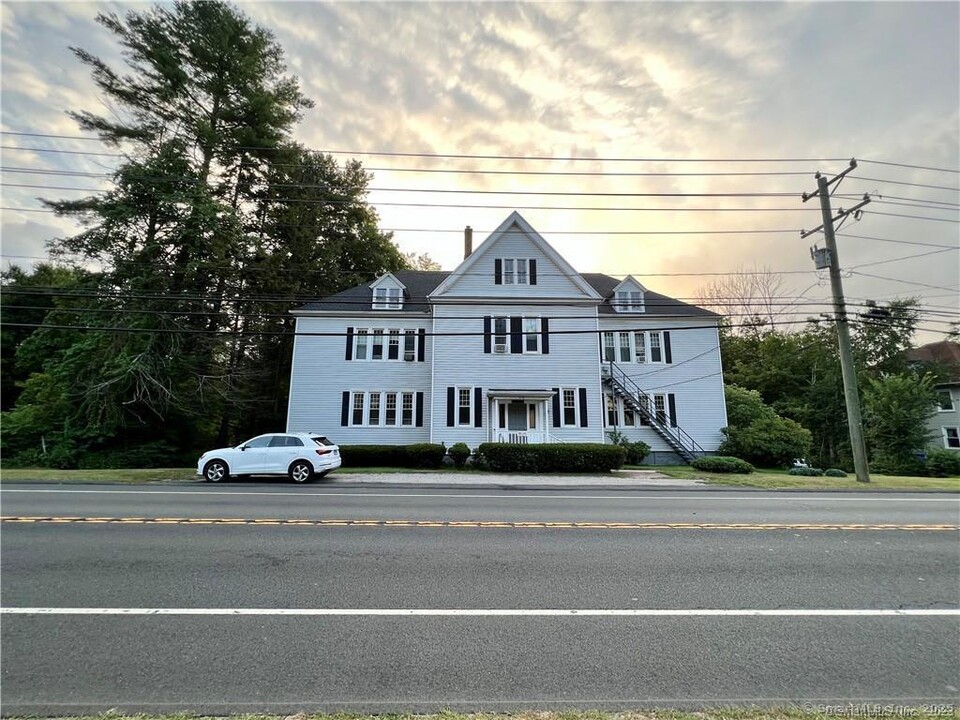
[432,305,604,448]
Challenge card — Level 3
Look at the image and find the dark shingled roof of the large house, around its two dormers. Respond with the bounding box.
[294,270,716,316]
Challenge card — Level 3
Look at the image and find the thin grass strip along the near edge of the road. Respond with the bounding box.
[28,703,960,720]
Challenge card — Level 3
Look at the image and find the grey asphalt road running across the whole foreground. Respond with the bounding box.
[0,485,960,714]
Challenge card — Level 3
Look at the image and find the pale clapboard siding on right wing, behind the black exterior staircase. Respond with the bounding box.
[595,315,727,452]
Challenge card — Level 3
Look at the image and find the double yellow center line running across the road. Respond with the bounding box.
[0,515,960,532]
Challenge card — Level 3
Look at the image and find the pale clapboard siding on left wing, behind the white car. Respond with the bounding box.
[287,314,432,445]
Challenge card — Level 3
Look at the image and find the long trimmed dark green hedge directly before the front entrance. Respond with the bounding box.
[477,443,626,473]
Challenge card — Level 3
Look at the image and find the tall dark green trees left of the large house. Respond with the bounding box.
[3,0,407,465]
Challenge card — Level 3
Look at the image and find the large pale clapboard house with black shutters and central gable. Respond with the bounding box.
[287,212,727,462]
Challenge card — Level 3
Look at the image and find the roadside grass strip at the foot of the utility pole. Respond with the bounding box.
[650,465,960,492]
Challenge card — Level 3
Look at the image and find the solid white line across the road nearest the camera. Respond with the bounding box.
[0,607,960,617]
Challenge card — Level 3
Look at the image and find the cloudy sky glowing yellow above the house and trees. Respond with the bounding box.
[2,2,960,339]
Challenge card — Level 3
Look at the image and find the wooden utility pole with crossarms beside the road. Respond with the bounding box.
[800,160,870,483]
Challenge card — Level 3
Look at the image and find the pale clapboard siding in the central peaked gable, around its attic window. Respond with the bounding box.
[443,226,587,299]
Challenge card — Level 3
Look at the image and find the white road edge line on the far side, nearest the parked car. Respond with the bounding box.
[0,487,960,503]
